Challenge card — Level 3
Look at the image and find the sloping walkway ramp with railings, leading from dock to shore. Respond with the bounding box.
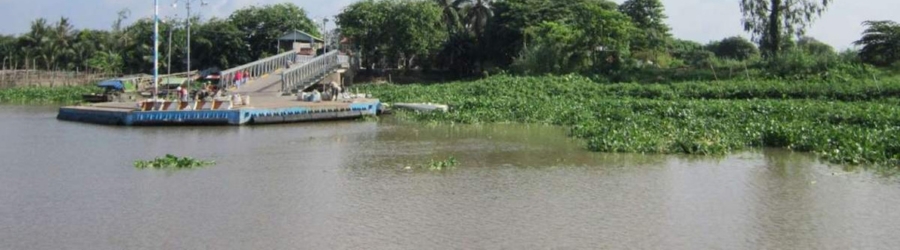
[222,51,348,95]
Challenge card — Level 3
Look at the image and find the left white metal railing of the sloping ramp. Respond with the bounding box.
[219,50,312,88]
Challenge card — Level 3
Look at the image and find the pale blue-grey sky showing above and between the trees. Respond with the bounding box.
[0,0,900,49]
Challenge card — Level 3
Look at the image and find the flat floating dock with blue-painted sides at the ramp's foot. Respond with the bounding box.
[56,96,381,126]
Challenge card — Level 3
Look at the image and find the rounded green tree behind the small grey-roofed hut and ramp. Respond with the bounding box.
[228,3,319,59]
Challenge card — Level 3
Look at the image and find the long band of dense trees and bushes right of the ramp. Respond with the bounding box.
[338,0,896,83]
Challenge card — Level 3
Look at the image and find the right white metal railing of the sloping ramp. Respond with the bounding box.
[281,51,341,93]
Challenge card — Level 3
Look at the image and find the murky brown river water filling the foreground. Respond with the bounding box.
[0,106,900,249]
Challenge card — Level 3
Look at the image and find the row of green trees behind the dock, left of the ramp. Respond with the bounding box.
[0,3,320,74]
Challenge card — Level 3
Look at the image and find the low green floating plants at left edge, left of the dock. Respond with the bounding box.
[0,86,103,103]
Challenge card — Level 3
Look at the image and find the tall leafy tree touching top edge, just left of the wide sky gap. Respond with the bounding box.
[619,0,671,50]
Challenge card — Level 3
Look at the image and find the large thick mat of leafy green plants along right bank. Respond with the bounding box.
[360,76,900,169]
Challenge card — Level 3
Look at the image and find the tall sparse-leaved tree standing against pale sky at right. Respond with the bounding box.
[740,0,834,56]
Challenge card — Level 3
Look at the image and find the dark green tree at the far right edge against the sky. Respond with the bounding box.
[853,21,900,66]
